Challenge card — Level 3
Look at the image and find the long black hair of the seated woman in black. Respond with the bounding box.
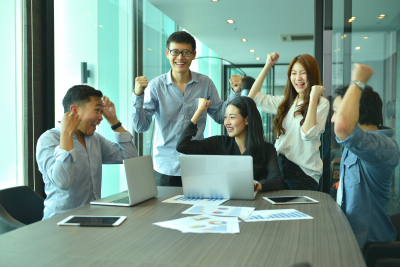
[228,96,266,165]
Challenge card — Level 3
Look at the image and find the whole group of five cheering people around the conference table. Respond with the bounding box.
[36,32,400,251]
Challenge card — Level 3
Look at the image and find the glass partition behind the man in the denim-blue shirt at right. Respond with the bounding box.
[324,0,400,214]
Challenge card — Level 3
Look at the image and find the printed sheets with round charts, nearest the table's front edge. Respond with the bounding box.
[154,215,240,234]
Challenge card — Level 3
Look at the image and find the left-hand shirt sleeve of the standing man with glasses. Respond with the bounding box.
[131,82,158,133]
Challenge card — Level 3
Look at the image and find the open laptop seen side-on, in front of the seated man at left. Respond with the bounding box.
[90,155,158,207]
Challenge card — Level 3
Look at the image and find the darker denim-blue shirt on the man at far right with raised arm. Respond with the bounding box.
[336,124,400,248]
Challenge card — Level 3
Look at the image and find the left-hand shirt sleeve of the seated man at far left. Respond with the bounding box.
[36,132,76,190]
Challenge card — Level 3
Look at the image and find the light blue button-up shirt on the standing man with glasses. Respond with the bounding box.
[132,70,239,176]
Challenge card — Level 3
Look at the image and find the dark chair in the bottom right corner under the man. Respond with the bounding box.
[363,213,400,267]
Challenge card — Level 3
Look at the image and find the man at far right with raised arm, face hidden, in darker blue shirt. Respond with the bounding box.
[332,63,400,248]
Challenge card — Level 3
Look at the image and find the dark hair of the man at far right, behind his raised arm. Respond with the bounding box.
[335,86,383,126]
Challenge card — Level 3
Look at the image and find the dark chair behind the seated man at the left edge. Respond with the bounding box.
[0,186,44,234]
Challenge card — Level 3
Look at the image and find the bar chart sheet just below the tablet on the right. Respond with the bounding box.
[242,209,313,222]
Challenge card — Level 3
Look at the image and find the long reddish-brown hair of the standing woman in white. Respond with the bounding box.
[272,54,321,139]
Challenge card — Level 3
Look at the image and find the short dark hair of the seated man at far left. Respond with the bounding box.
[63,85,103,113]
